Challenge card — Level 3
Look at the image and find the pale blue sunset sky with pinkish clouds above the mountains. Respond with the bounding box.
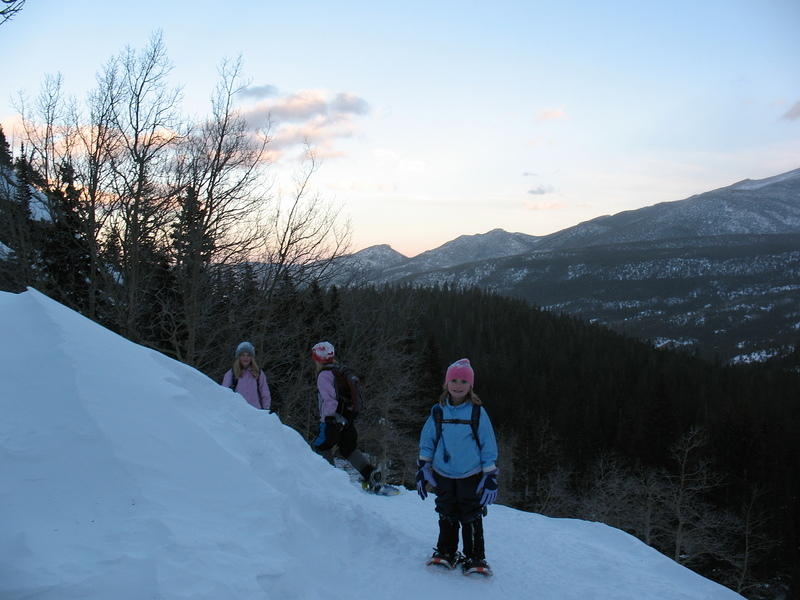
[0,0,800,256]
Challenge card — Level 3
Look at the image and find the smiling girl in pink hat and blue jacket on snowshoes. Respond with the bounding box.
[417,358,498,575]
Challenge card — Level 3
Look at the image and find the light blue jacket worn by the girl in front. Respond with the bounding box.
[419,399,497,479]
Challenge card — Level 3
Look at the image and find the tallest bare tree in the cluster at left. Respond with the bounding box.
[110,33,181,340]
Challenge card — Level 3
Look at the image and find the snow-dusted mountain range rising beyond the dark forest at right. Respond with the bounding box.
[342,169,800,362]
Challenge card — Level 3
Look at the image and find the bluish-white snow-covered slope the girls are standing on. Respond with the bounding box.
[0,290,740,600]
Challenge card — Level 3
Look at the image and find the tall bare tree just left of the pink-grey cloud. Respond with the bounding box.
[166,59,270,367]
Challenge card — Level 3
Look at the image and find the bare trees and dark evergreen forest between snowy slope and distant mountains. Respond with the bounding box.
[0,36,800,598]
